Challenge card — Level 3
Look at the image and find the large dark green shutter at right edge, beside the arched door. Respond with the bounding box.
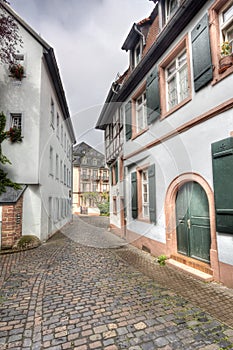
[212,137,233,233]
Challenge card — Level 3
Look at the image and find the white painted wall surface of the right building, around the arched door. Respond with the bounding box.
[122,2,233,265]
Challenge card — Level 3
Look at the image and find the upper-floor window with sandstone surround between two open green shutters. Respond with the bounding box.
[159,36,191,117]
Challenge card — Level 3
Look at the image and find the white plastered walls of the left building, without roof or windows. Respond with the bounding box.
[0,14,72,240]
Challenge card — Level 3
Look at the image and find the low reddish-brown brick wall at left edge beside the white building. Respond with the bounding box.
[1,196,23,249]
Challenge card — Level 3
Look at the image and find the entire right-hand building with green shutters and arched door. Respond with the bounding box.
[97,0,233,287]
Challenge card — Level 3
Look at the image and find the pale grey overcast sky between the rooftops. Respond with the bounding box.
[10,0,154,151]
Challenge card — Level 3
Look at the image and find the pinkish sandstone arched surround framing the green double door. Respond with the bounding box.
[165,173,219,281]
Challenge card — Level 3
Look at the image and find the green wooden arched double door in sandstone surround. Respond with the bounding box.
[176,182,210,262]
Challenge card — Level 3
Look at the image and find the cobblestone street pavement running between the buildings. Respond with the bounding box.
[0,218,233,350]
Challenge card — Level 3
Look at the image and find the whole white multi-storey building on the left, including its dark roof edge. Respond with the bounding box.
[0,4,75,246]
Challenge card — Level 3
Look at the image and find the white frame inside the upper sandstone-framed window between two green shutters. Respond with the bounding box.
[165,49,189,111]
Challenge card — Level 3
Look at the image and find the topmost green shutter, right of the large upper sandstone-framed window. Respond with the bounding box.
[191,14,213,91]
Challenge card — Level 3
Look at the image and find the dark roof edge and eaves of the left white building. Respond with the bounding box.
[0,0,76,143]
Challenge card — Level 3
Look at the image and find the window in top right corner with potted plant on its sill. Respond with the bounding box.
[220,3,233,52]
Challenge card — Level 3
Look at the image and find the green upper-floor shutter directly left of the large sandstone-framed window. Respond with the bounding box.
[146,67,160,125]
